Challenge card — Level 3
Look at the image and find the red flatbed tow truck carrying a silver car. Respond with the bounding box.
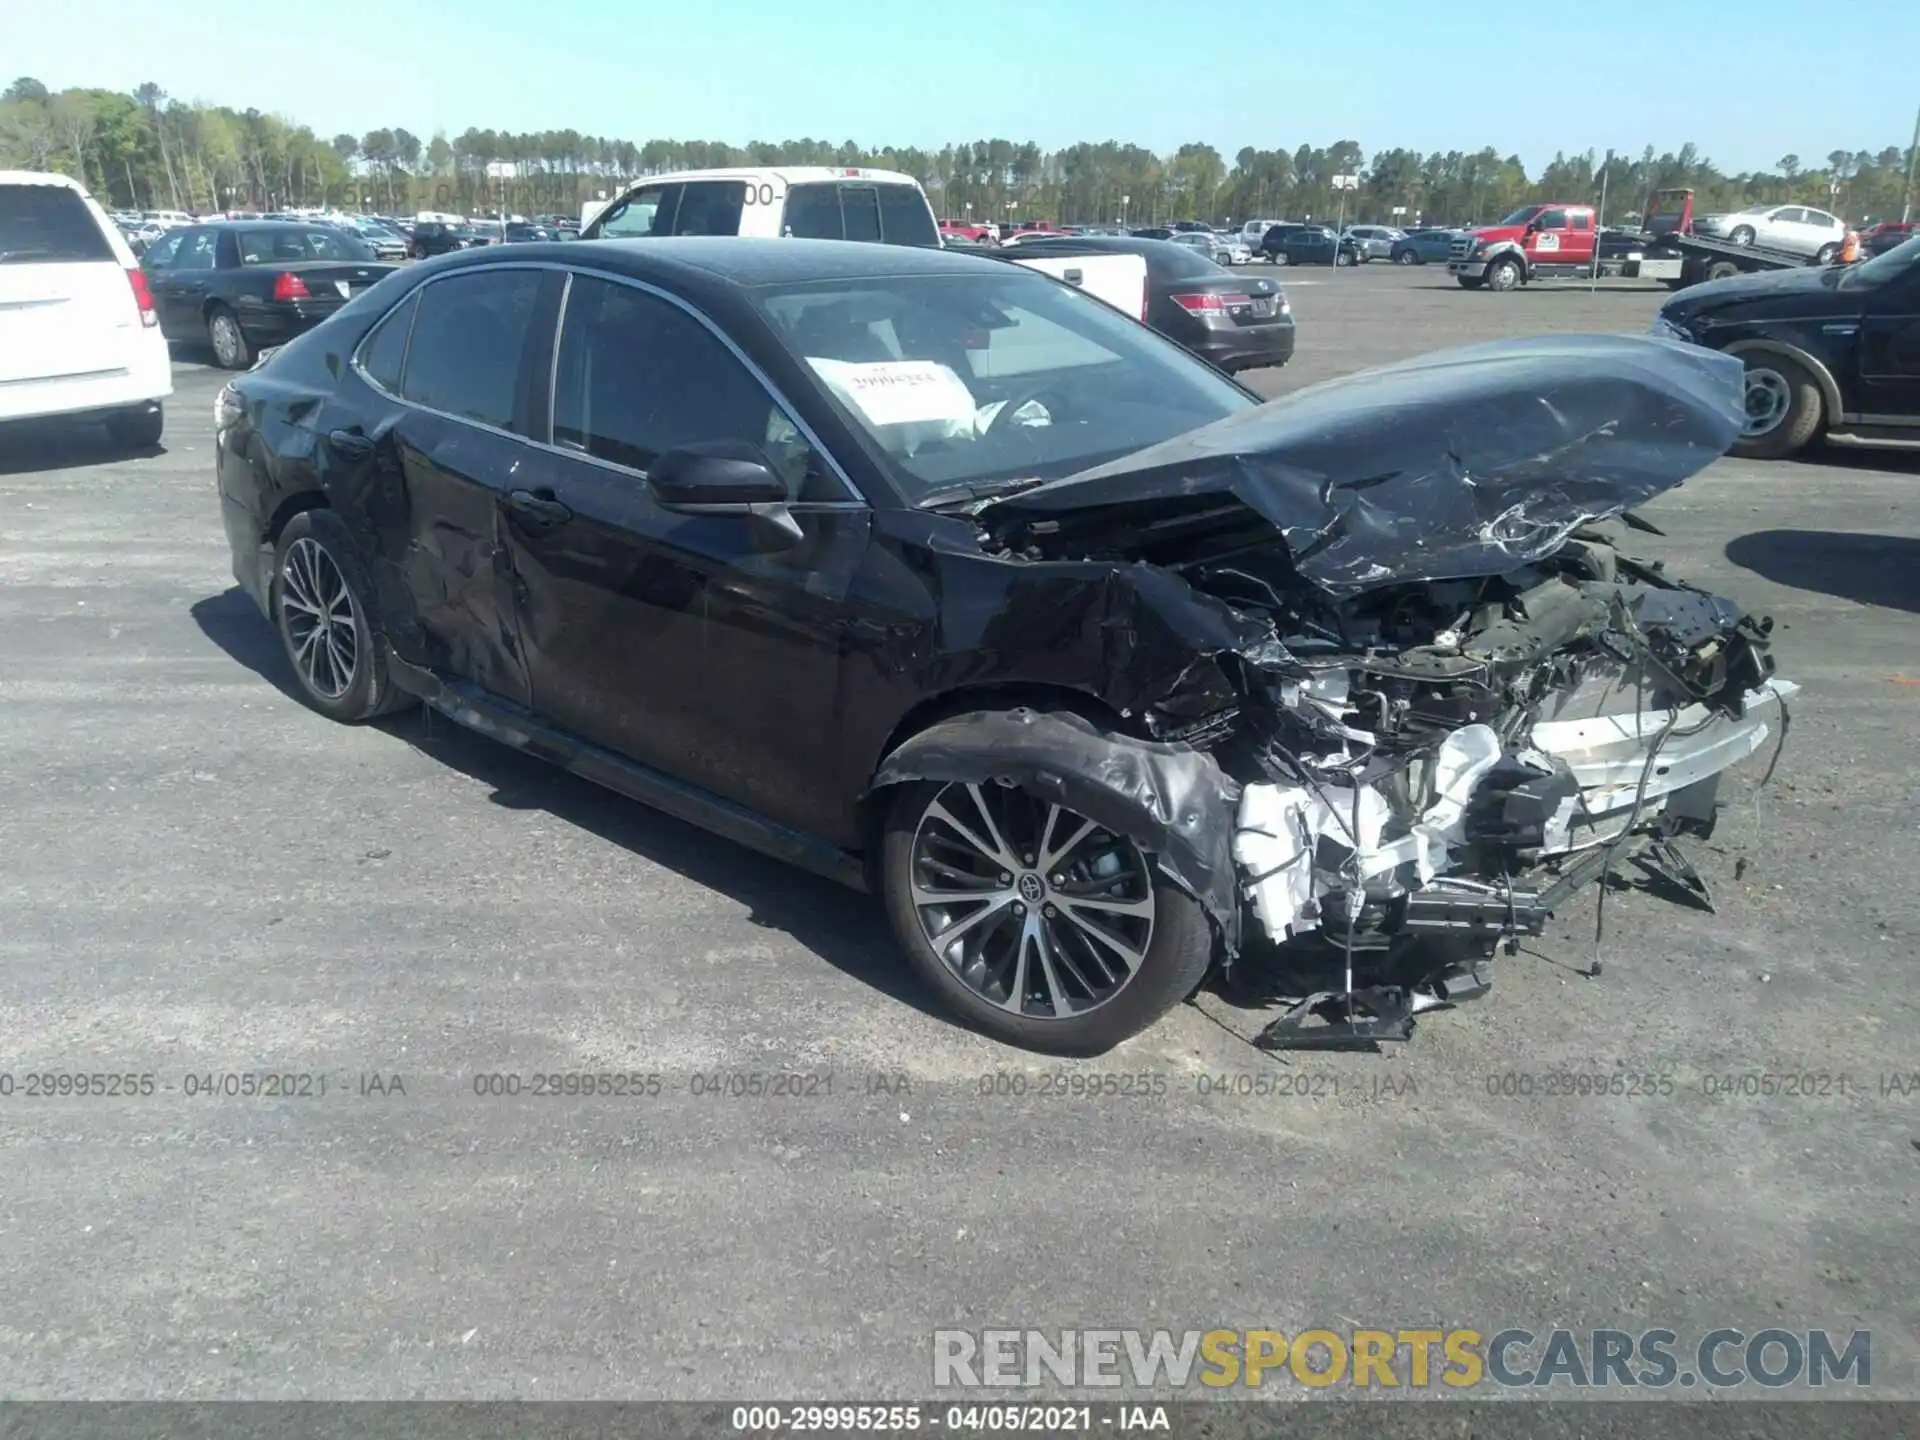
[1446,190,1812,290]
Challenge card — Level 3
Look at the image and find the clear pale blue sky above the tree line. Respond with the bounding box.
[15,0,1920,171]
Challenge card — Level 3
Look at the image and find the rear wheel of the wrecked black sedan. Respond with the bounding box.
[269,511,413,724]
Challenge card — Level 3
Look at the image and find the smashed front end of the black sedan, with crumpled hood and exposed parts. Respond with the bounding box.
[960,336,1797,1048]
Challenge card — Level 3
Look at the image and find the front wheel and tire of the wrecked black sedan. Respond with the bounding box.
[881,781,1213,1056]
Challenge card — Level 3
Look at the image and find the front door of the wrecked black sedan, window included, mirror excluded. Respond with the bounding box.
[503,273,872,839]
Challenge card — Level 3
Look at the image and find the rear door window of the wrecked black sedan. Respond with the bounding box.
[399,271,541,430]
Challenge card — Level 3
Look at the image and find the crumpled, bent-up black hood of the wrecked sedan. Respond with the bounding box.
[991,334,1745,595]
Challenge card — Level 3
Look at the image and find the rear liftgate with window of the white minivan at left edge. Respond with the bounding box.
[0,182,140,384]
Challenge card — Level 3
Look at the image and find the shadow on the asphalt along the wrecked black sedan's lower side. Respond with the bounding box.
[192,586,929,1021]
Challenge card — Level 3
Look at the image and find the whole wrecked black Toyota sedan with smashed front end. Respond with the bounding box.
[217,238,1793,1054]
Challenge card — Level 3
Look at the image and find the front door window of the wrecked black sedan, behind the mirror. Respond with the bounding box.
[553,275,817,499]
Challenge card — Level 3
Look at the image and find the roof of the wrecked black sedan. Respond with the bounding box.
[434,234,1004,286]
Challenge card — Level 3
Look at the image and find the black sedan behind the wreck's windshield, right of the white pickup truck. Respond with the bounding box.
[990,234,1294,372]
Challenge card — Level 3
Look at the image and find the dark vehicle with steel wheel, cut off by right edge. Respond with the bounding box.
[1653,236,1920,459]
